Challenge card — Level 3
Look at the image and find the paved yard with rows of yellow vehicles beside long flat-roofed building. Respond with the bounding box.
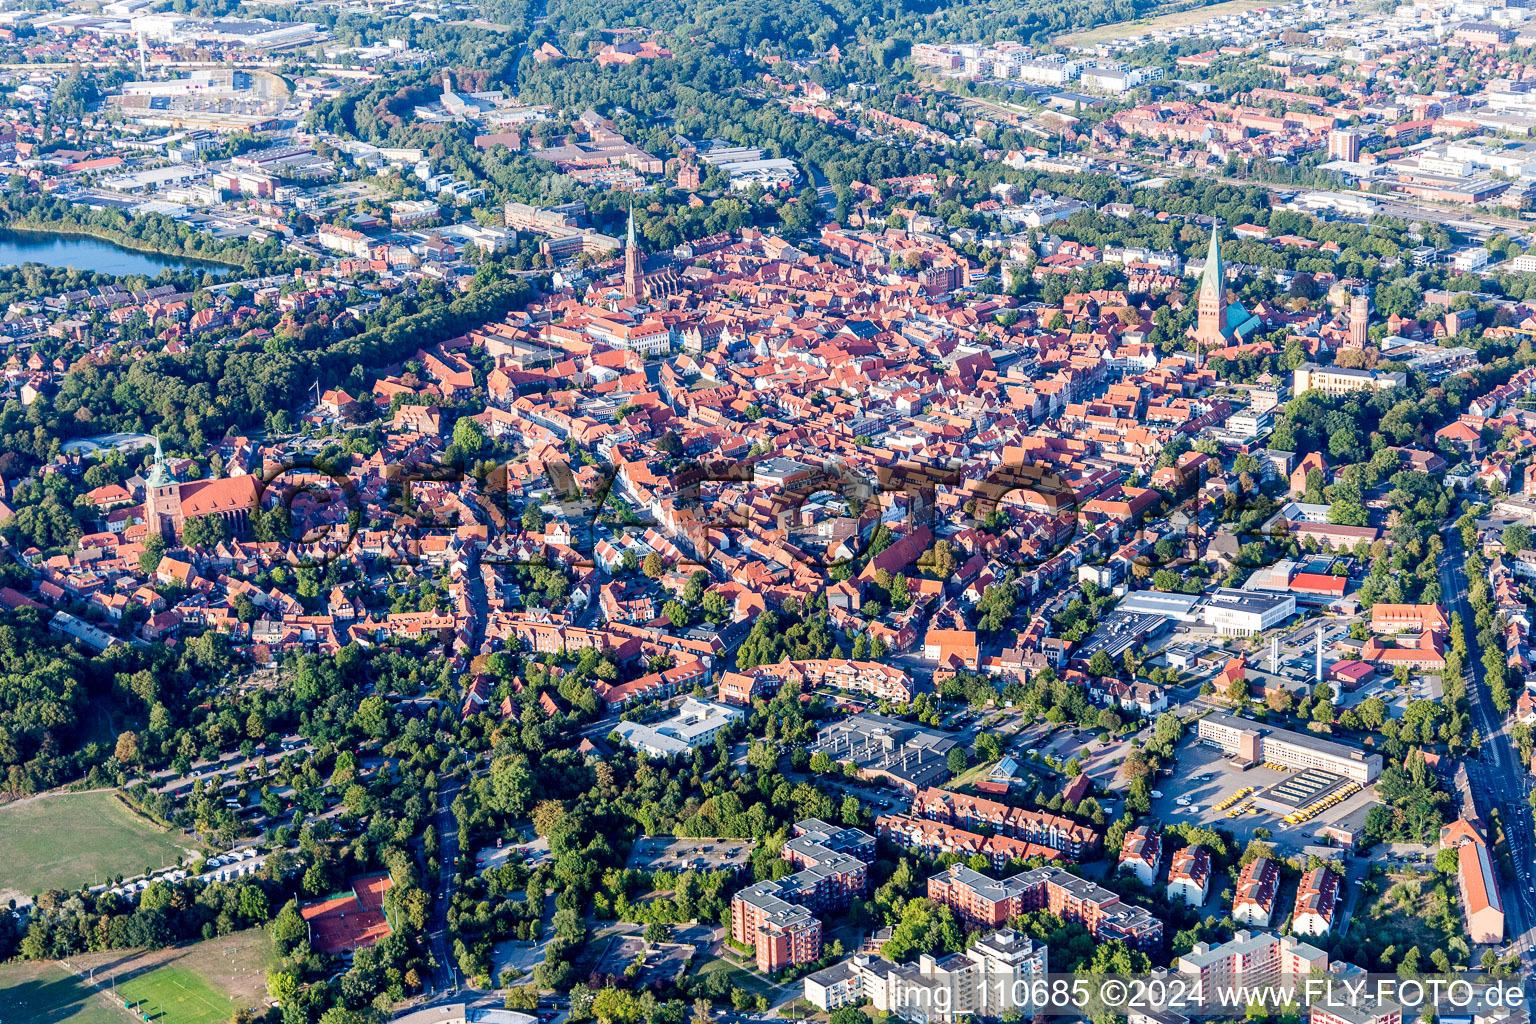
[1152,737,1376,855]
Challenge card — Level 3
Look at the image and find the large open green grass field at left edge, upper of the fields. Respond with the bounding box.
[0,791,201,897]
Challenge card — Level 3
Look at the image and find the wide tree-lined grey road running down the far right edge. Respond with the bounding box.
[1441,530,1536,955]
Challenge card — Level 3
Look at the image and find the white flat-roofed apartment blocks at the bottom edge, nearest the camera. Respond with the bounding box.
[805,929,1049,1024]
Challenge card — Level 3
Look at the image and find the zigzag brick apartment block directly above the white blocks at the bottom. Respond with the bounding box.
[928,864,1163,950]
